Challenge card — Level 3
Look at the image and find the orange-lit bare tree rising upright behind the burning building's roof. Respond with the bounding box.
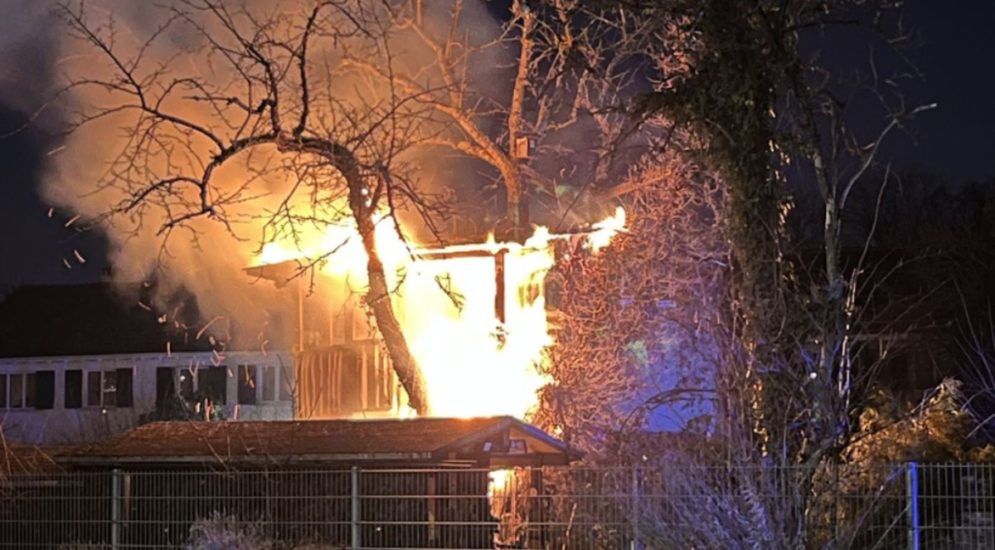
[349,0,653,240]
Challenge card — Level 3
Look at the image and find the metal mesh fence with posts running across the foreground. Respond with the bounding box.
[0,464,995,550]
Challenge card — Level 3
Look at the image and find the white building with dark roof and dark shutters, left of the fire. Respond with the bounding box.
[0,284,294,444]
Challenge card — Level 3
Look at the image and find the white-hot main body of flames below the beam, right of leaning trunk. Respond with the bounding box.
[395,244,553,418]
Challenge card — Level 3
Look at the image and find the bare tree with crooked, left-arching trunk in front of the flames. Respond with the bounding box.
[59,0,429,413]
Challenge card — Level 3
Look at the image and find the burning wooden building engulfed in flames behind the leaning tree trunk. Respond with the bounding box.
[248,210,624,418]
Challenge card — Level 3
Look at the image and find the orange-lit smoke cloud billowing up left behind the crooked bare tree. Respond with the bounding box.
[21,0,506,349]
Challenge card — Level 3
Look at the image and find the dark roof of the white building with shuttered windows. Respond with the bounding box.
[0,283,211,357]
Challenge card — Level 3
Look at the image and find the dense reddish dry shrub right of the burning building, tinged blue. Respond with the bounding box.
[532,152,727,459]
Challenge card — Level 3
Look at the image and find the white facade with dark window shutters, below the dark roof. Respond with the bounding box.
[0,352,294,445]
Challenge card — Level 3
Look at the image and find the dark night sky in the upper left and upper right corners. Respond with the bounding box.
[0,0,995,288]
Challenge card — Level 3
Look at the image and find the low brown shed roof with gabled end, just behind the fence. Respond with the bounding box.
[56,416,580,467]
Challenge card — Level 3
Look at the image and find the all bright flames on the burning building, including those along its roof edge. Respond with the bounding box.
[251,208,625,418]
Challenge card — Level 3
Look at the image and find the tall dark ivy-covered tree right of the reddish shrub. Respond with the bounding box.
[628,0,931,463]
